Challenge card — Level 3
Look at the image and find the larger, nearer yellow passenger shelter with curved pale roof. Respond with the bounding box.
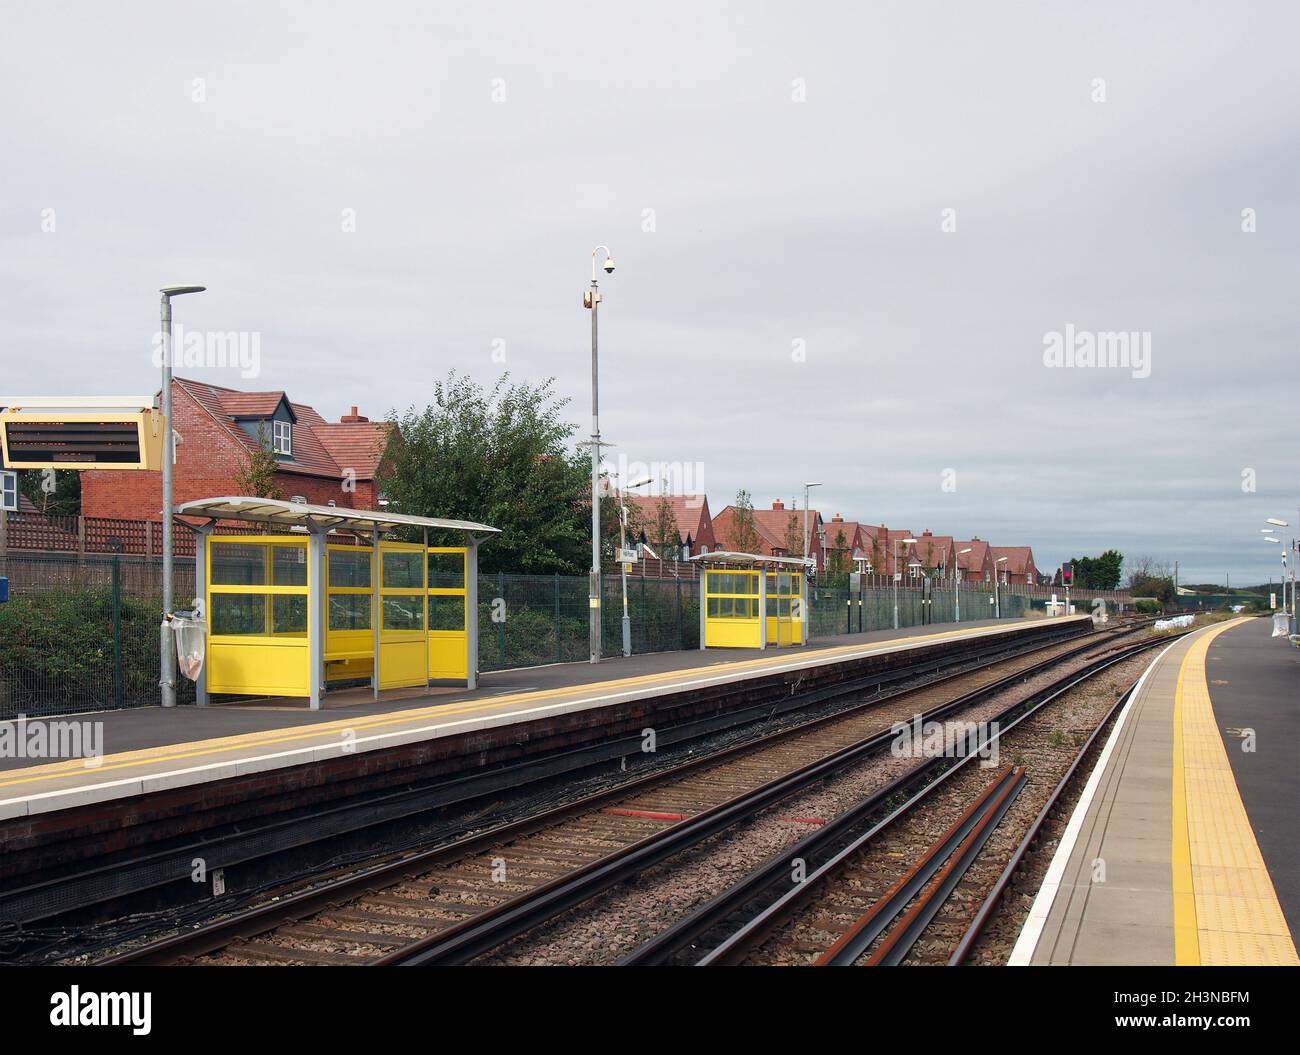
[176,496,498,709]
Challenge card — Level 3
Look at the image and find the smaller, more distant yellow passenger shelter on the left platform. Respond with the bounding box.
[689,551,813,648]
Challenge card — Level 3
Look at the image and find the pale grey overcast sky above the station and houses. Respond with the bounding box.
[0,0,1300,582]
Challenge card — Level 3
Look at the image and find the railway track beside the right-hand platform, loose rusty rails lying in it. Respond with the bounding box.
[620,639,1180,965]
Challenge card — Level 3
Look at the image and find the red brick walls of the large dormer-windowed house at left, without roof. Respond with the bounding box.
[82,387,374,520]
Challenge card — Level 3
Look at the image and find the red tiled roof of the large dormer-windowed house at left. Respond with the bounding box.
[176,377,389,479]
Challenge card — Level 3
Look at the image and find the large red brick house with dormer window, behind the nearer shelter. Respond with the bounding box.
[82,378,390,520]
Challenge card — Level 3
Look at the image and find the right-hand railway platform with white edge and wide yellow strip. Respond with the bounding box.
[1010,618,1300,965]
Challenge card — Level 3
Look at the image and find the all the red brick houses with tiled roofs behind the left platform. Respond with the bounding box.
[0,378,1040,586]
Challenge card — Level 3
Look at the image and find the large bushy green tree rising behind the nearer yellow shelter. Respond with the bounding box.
[380,370,595,574]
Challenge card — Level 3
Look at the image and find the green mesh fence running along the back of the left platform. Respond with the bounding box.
[0,555,1041,717]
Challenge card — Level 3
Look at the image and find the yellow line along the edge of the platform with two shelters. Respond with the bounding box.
[0,620,1066,787]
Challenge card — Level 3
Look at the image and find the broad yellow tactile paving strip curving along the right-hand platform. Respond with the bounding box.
[1170,618,1300,967]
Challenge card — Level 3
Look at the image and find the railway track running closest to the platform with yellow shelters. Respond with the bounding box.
[96,618,1154,965]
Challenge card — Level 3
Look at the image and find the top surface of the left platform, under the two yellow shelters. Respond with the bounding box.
[0,616,1088,820]
